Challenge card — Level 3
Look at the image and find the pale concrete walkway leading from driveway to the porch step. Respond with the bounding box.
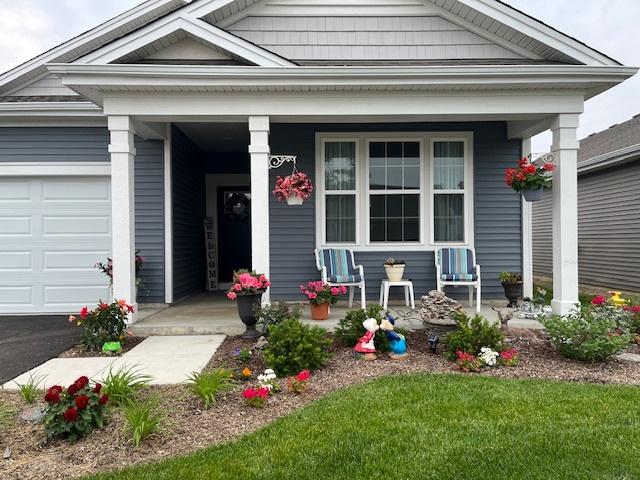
[3,335,225,390]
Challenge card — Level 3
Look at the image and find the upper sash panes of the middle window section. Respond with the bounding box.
[369,142,420,190]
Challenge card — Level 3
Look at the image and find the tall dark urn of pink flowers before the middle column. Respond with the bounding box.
[227,270,271,338]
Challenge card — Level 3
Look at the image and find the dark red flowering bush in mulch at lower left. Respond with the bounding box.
[44,377,109,442]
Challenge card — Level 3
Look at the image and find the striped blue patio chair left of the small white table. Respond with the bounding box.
[315,248,367,309]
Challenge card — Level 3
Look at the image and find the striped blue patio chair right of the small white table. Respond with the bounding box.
[435,248,481,312]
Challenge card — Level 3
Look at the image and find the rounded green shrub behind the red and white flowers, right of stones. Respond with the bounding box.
[443,312,504,360]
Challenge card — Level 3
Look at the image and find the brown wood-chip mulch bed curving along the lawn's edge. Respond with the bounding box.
[0,330,640,480]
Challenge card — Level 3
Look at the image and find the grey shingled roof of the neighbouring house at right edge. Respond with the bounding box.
[578,114,640,172]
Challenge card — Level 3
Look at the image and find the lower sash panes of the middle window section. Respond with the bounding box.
[369,194,420,242]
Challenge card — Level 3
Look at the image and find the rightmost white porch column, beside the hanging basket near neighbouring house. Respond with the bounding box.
[551,114,580,315]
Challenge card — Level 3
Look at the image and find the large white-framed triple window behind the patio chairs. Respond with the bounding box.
[316,132,474,251]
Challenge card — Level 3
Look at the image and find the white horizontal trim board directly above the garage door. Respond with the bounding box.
[0,162,111,177]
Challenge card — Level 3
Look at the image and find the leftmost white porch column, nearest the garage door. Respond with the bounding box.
[108,116,138,323]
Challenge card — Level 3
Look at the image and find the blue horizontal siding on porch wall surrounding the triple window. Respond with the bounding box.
[270,122,522,300]
